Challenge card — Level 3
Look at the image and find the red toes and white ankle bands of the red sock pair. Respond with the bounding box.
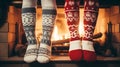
[69,40,96,62]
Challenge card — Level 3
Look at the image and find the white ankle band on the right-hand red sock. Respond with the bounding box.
[82,41,95,51]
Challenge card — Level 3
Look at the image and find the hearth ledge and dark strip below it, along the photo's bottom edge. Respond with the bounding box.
[0,56,120,67]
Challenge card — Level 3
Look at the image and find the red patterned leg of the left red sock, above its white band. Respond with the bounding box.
[65,0,80,41]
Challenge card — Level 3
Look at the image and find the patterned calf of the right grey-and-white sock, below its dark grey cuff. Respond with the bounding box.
[41,15,56,45]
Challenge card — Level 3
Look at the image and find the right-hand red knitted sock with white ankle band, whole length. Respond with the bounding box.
[82,0,99,61]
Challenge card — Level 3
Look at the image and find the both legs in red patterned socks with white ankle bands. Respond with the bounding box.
[65,0,99,61]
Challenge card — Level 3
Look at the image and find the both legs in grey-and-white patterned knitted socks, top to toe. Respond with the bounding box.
[22,0,57,63]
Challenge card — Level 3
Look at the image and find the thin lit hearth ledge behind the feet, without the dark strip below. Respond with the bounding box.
[0,56,120,62]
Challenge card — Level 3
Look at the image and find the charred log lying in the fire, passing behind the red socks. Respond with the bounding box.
[52,32,102,45]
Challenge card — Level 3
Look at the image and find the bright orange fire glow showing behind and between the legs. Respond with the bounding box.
[35,8,109,45]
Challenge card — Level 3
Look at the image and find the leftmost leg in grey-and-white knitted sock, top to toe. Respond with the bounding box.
[22,0,37,63]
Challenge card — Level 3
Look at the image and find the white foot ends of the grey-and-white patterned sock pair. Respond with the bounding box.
[24,44,51,63]
